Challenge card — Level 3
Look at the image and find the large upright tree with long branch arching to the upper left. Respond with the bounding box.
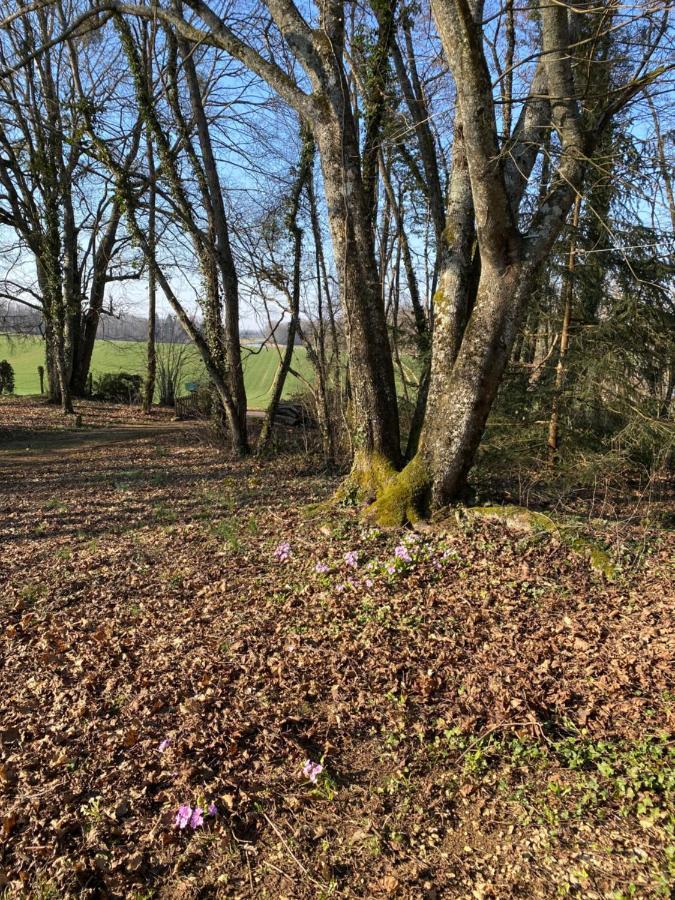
[41,0,401,478]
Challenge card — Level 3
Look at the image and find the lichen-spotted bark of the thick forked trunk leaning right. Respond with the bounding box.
[370,0,624,525]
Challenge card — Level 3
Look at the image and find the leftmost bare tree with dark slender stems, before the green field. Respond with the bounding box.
[0,2,138,411]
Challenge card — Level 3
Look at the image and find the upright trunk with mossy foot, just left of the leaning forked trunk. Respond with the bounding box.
[311,10,401,482]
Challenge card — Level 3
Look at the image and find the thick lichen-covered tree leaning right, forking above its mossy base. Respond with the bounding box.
[372,0,667,524]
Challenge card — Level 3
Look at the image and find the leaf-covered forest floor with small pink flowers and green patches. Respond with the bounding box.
[0,399,675,900]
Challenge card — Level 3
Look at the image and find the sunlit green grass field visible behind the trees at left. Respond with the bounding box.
[0,335,312,409]
